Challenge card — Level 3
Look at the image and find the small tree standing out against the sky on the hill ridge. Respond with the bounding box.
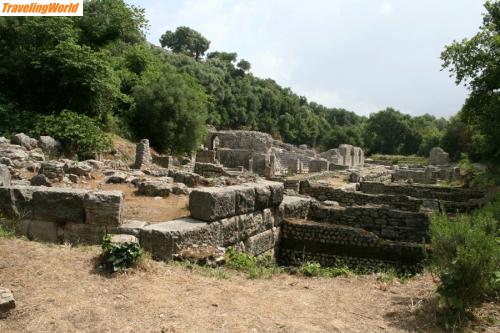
[160,27,210,60]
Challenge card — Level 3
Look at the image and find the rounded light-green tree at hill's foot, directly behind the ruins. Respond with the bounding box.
[132,66,207,154]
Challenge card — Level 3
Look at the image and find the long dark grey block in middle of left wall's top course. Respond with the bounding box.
[33,188,88,223]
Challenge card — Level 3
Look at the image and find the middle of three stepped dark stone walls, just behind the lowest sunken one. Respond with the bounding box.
[308,203,430,243]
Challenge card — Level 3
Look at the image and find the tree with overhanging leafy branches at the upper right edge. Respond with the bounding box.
[441,0,500,161]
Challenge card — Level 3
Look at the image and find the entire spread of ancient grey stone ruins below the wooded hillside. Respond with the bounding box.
[0,130,484,269]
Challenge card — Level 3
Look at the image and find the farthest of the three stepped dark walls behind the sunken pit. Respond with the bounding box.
[300,181,422,212]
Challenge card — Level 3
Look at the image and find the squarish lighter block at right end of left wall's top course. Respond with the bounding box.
[83,191,123,226]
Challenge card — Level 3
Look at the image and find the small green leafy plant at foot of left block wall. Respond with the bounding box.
[101,235,143,273]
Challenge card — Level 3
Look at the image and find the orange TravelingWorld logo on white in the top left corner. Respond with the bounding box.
[0,0,83,16]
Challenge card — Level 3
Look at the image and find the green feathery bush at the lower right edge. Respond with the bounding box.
[430,212,500,324]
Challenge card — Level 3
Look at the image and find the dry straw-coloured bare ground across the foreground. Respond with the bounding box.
[0,238,468,333]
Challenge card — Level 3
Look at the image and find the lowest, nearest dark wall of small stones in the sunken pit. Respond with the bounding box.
[277,219,425,269]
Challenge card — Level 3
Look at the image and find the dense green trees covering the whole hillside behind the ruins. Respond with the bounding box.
[0,0,484,159]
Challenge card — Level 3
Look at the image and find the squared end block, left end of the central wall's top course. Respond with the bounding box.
[189,187,236,222]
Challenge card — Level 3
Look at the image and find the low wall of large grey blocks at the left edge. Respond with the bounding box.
[0,186,123,244]
